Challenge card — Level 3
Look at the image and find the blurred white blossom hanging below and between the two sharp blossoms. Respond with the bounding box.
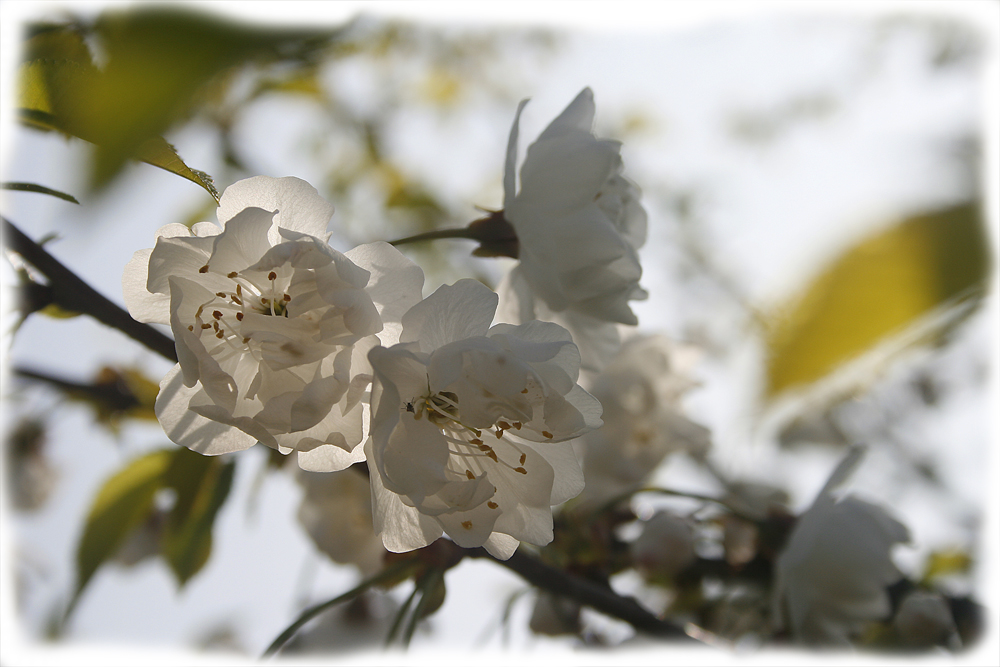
[295,466,385,576]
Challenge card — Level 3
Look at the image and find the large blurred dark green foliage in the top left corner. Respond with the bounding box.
[19,5,334,197]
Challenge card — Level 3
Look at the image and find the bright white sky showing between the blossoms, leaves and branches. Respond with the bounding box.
[0,2,1000,664]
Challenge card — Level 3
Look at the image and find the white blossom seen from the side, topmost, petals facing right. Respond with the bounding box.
[499,88,647,370]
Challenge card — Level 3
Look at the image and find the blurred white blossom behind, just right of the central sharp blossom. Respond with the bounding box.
[576,335,710,506]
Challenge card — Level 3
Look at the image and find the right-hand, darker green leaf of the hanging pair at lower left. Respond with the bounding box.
[161,449,236,586]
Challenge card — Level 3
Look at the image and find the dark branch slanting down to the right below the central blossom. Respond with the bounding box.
[466,548,696,642]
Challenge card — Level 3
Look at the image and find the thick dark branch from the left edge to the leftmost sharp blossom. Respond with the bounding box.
[3,218,177,362]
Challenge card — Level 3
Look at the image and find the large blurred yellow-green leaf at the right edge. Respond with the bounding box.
[766,202,991,398]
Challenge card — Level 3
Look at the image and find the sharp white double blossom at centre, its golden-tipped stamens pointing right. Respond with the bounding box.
[365,280,601,559]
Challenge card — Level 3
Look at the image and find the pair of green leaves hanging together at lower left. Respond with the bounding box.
[66,447,235,617]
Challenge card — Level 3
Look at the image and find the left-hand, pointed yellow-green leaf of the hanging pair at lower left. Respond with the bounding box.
[66,449,175,616]
